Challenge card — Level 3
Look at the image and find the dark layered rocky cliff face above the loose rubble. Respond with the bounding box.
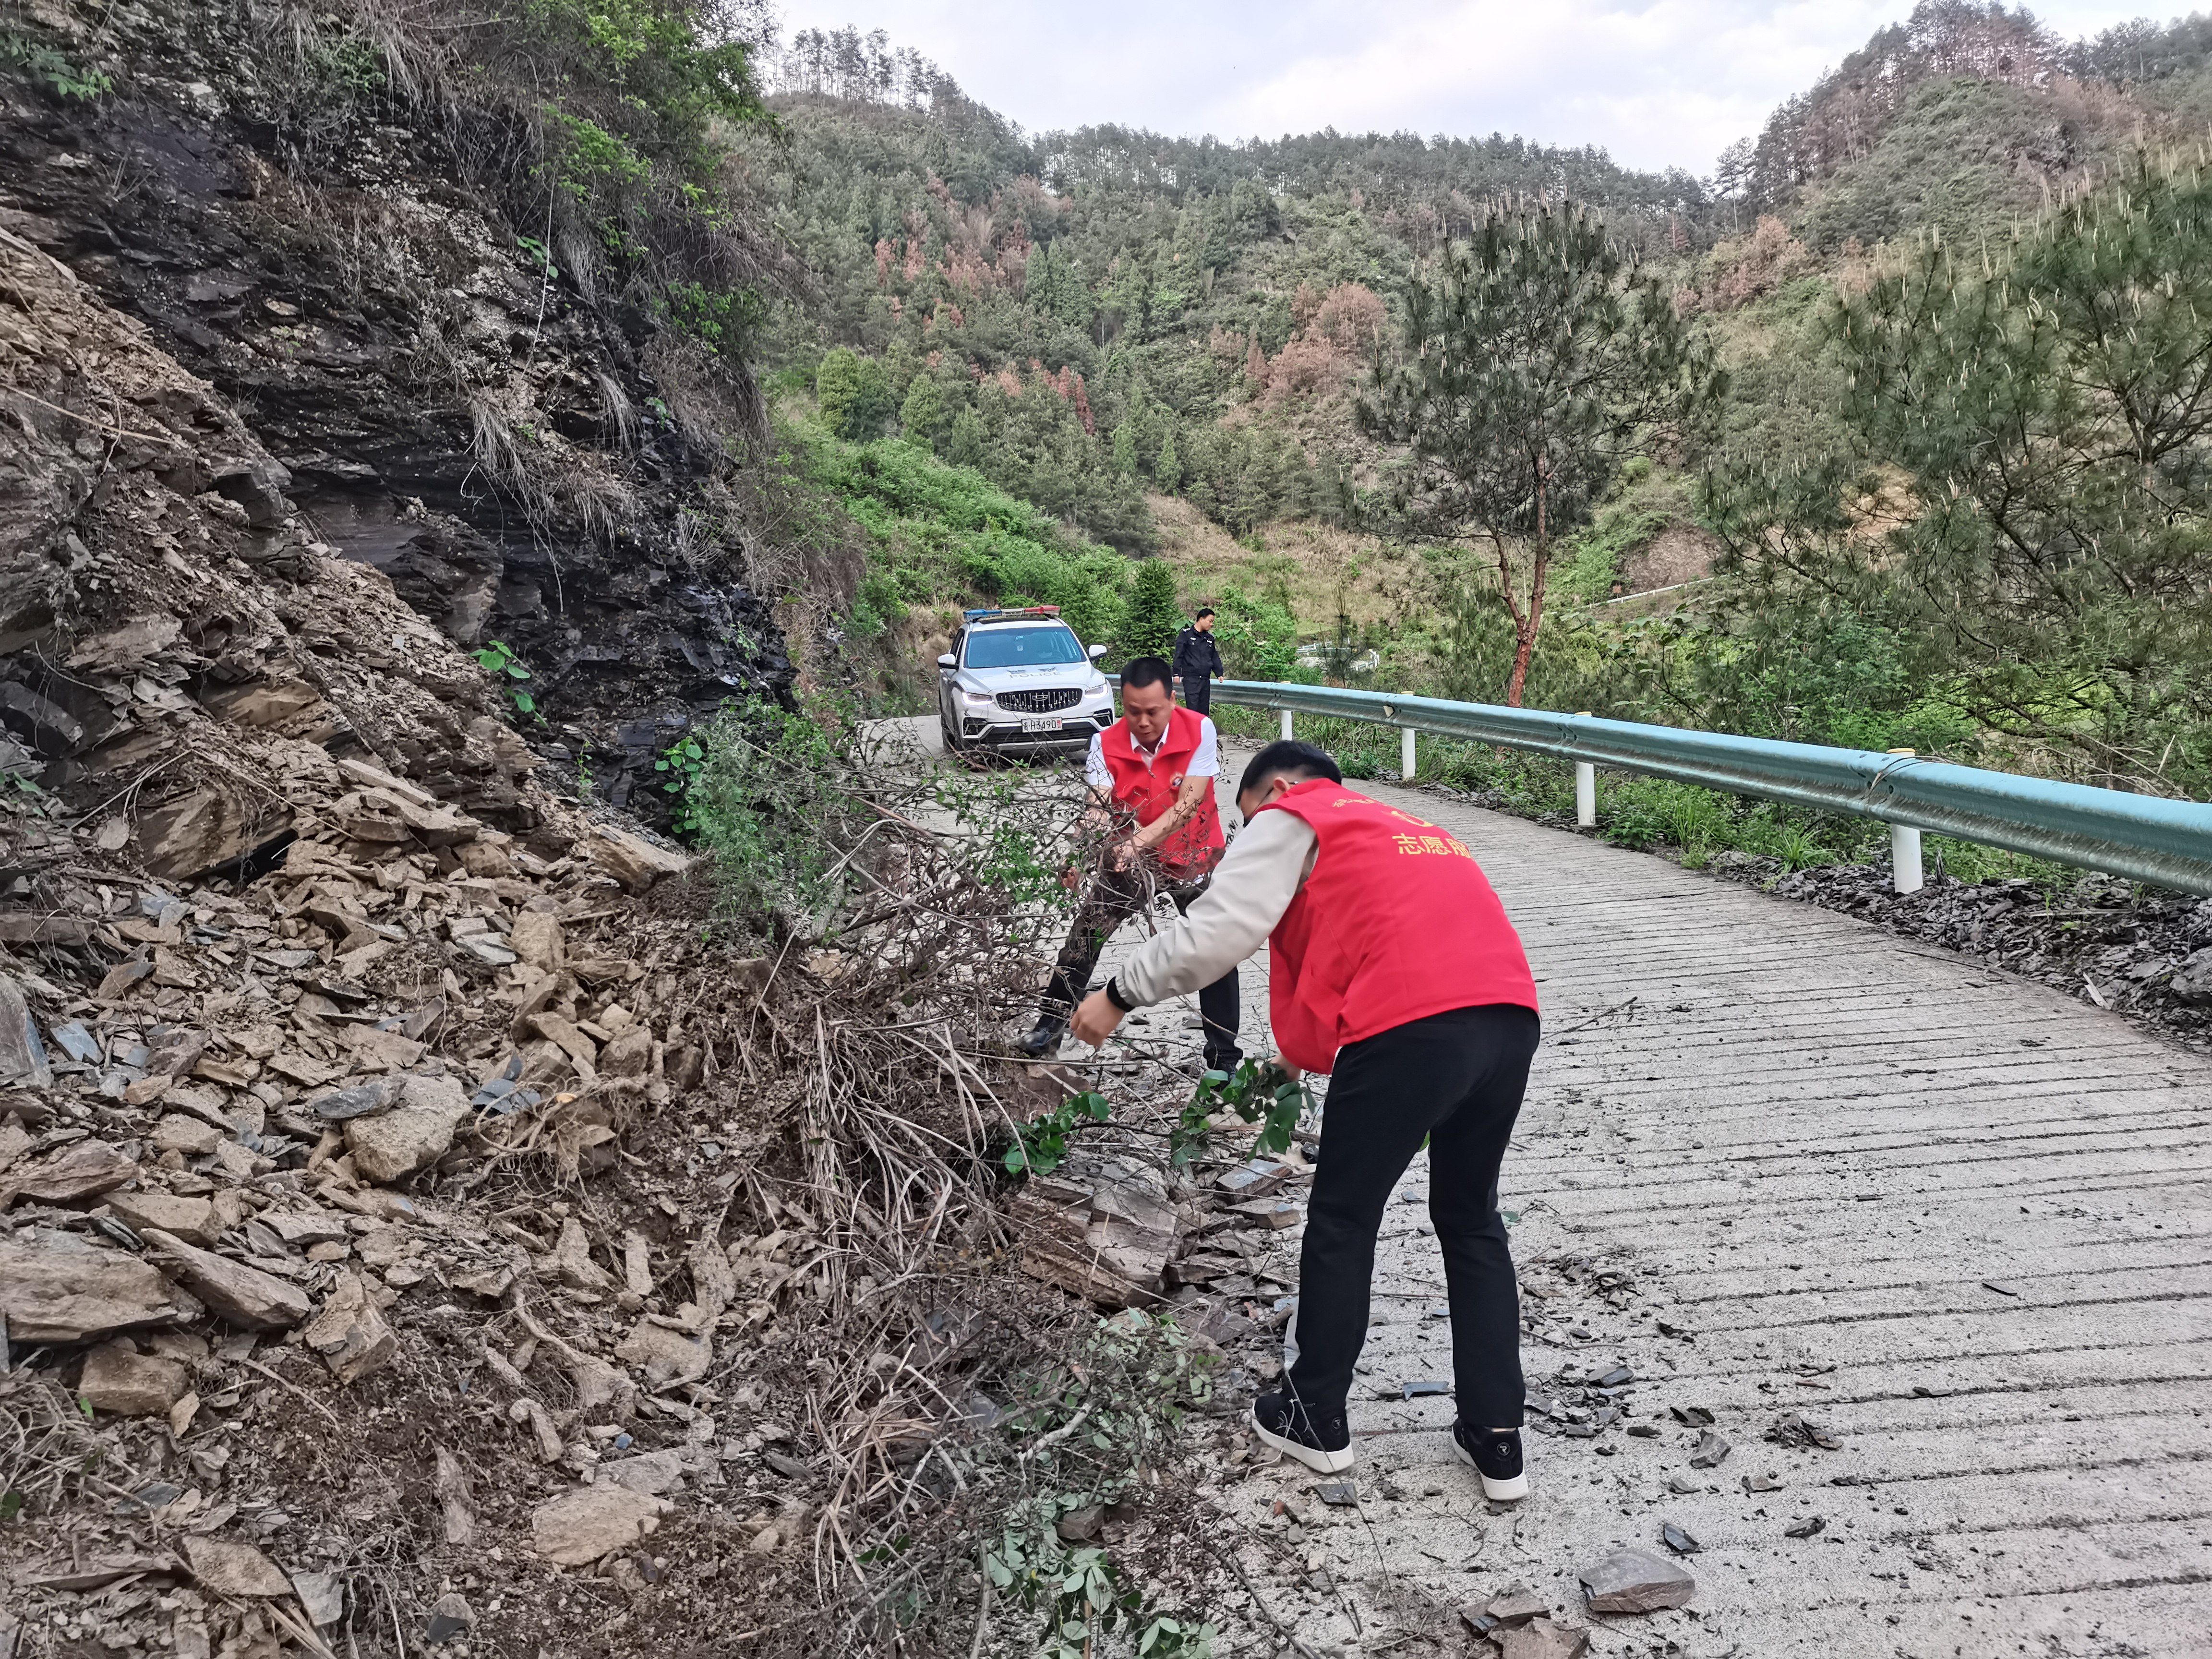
[0,0,814,805]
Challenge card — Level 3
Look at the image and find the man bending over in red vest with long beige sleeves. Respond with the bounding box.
[1075,743,1538,1500]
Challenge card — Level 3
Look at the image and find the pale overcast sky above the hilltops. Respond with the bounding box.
[783,0,2168,175]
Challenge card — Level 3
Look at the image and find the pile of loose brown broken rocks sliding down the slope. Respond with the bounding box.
[0,232,933,1657]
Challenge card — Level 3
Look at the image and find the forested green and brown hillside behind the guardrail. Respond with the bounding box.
[752,2,2212,818]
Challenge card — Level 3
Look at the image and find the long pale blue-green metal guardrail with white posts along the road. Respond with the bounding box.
[1123,679,2212,896]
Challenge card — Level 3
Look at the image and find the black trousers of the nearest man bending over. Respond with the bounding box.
[1289,1002,1539,1429]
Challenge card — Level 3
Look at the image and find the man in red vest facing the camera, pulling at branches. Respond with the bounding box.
[1015,657,1243,1070]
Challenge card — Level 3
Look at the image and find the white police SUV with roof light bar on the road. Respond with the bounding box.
[938,604,1113,754]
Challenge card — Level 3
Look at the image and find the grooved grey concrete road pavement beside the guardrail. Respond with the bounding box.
[931,734,2212,1659]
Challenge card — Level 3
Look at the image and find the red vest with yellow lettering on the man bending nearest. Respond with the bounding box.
[1261,779,1538,1070]
